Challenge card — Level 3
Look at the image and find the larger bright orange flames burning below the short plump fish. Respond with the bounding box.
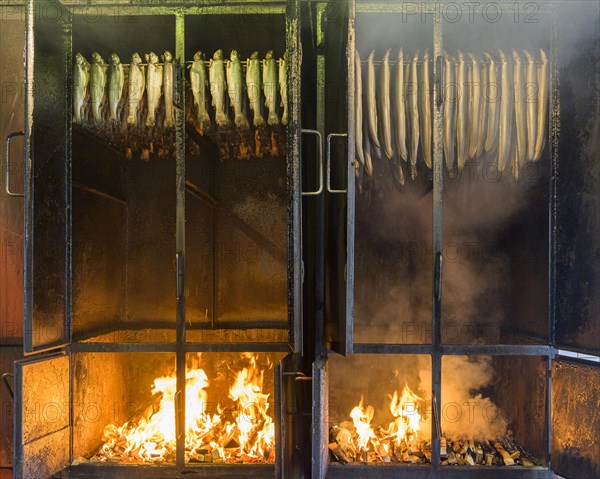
[96,353,275,463]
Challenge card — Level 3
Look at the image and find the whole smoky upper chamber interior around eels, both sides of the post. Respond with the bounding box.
[354,5,554,344]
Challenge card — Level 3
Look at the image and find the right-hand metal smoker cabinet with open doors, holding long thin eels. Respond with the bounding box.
[312,0,600,478]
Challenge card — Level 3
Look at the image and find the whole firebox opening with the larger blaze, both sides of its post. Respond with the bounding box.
[75,353,282,464]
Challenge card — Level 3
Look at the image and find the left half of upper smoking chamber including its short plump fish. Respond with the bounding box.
[72,13,176,342]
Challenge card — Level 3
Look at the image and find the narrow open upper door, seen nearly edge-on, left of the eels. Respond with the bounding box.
[326,0,355,355]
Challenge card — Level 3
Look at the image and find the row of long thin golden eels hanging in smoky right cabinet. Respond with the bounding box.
[355,49,549,184]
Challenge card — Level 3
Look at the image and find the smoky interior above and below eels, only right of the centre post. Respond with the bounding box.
[442,9,554,344]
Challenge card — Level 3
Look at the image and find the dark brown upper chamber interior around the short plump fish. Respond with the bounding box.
[72,14,288,342]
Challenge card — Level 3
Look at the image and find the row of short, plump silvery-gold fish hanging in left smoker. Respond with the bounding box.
[73,50,287,131]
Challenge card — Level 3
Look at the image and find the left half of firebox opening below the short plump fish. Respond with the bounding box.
[73,352,176,465]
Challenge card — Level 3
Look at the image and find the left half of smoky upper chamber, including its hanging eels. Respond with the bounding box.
[354,4,433,344]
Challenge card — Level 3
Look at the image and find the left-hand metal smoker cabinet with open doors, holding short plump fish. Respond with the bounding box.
[15,0,310,478]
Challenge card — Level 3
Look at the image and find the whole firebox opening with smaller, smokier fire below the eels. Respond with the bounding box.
[329,354,546,467]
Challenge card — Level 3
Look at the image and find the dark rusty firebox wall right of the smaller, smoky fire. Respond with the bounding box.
[490,356,549,465]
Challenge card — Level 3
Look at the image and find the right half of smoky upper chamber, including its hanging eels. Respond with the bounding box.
[442,8,554,344]
